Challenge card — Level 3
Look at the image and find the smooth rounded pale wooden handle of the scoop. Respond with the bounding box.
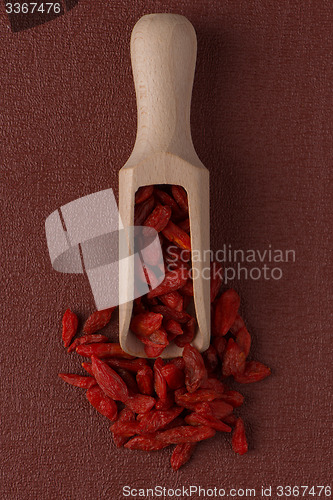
[131,14,201,163]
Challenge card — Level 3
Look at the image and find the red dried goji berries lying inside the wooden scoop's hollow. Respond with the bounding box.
[130,185,214,358]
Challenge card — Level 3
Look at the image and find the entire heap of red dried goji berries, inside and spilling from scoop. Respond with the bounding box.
[59,186,270,470]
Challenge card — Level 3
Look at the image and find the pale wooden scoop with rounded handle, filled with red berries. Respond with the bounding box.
[119,14,210,358]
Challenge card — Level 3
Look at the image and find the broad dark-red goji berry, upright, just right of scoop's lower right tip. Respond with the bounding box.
[214,288,240,335]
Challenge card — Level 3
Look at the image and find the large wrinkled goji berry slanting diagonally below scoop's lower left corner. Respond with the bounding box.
[91,356,129,403]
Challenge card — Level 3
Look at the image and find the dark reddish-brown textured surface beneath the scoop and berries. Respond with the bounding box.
[0,0,333,500]
